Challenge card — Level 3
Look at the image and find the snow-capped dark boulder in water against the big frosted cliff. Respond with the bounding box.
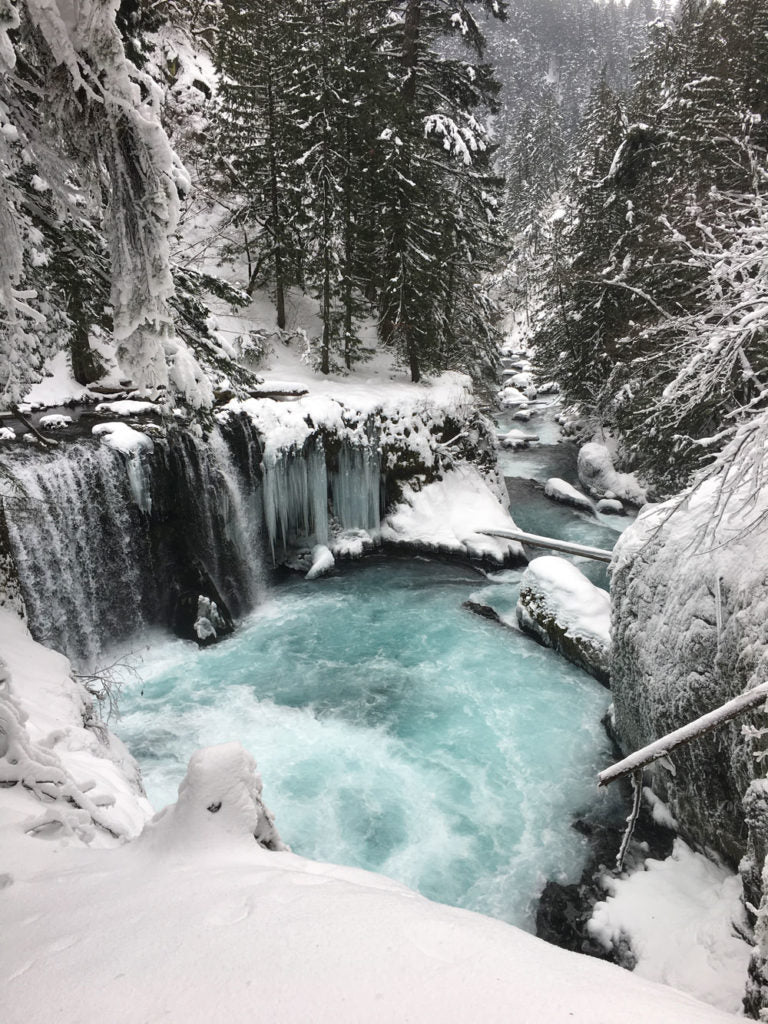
[516,555,610,686]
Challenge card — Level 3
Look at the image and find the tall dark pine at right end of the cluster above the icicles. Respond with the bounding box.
[375,0,512,381]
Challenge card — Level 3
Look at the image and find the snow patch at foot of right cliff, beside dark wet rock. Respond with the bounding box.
[588,839,752,1014]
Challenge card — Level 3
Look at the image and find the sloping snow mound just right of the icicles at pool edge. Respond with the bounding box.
[381,465,525,564]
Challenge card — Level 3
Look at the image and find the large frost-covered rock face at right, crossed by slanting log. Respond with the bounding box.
[611,471,768,1014]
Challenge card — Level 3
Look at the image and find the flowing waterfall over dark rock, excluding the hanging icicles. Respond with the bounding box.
[4,429,263,664]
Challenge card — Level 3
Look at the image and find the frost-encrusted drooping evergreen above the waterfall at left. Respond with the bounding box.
[0,0,210,404]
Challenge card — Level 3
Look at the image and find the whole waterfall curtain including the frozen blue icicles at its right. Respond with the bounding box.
[2,416,383,664]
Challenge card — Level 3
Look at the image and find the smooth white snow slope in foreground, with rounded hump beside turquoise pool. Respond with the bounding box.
[0,610,734,1024]
